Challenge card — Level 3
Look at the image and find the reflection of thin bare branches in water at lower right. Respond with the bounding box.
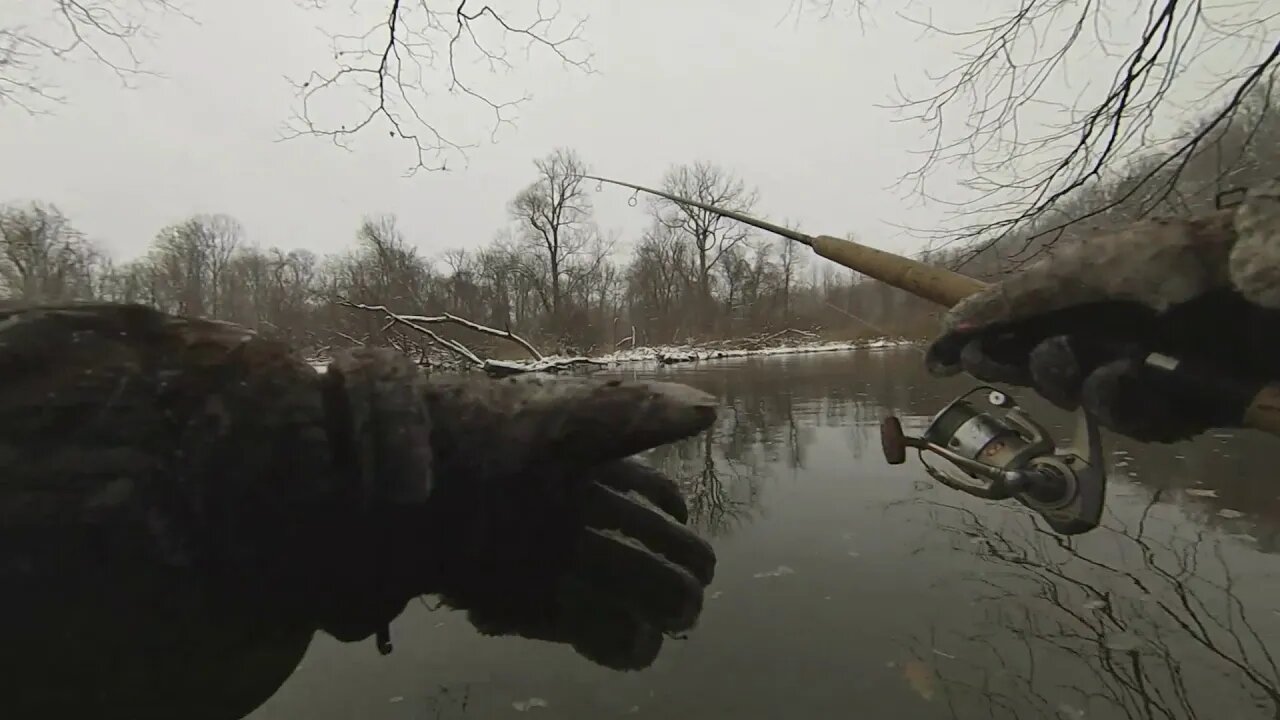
[890,491,1280,719]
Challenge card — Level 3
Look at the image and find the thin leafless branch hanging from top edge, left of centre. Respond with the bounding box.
[282,0,594,174]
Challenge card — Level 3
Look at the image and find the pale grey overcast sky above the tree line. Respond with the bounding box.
[0,0,1274,263]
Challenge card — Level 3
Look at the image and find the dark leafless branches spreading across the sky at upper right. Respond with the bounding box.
[893,0,1280,264]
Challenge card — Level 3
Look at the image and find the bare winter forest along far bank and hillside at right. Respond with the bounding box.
[0,76,1280,352]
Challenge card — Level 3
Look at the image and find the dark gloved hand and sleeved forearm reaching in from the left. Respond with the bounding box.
[0,304,716,720]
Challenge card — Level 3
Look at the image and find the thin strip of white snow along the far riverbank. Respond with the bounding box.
[311,338,916,375]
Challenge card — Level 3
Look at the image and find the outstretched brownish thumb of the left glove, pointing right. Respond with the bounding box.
[426,375,716,475]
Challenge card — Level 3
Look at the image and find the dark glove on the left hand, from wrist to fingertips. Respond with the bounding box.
[325,350,716,669]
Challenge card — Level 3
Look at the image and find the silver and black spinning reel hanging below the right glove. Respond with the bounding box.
[881,386,1106,536]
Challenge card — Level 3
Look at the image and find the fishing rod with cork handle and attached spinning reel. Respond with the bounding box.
[582,174,1280,536]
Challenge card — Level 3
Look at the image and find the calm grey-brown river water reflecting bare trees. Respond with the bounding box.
[250,348,1280,720]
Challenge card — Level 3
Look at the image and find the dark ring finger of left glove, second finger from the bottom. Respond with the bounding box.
[575,528,703,633]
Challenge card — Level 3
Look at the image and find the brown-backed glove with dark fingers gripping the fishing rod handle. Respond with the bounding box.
[927,182,1280,442]
